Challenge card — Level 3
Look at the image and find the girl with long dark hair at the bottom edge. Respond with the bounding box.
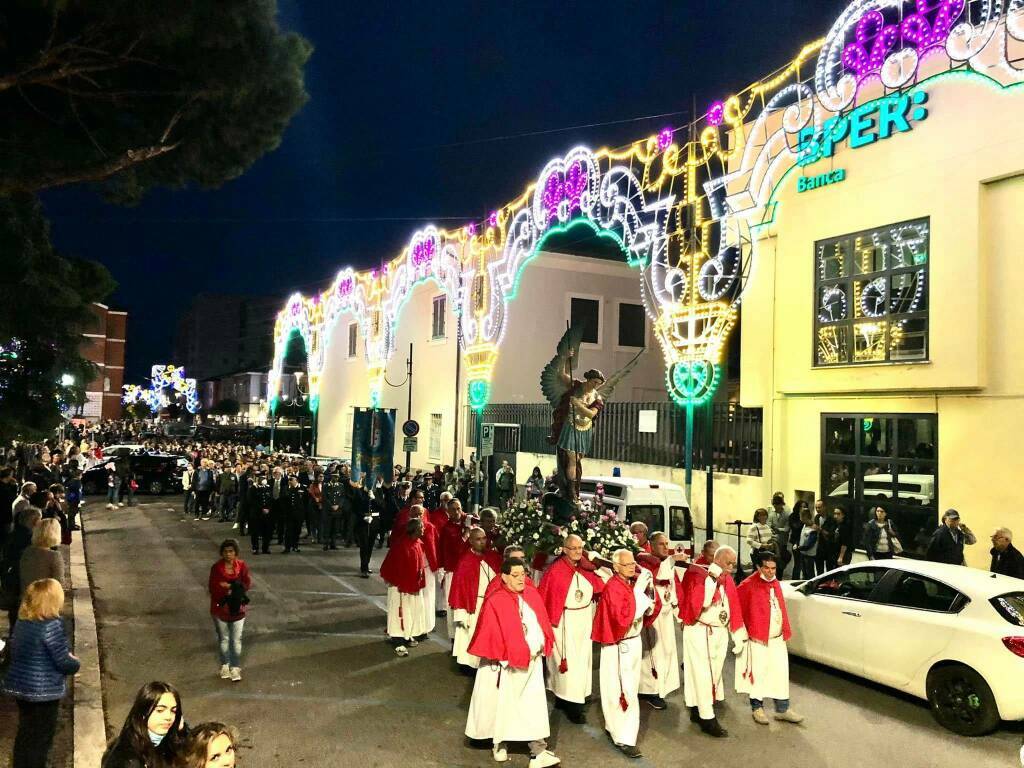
[101,681,187,768]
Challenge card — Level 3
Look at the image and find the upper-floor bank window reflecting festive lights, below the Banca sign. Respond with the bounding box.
[814,219,929,367]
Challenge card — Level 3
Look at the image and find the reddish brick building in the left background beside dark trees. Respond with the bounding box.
[81,302,128,421]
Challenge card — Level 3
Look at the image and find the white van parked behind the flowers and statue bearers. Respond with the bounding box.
[580,476,693,550]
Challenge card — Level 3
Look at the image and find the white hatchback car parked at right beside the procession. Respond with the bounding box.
[782,559,1024,736]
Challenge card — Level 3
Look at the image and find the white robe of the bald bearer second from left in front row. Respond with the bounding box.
[548,573,594,703]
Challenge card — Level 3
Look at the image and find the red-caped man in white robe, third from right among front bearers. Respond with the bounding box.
[637,530,689,710]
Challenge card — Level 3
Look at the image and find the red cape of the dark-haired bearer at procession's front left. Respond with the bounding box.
[469,584,555,670]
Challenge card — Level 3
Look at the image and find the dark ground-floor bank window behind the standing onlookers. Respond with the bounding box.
[821,414,939,555]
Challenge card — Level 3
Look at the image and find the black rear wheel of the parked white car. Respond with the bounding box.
[927,664,999,736]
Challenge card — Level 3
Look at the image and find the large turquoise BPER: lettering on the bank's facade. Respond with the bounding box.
[797,91,928,165]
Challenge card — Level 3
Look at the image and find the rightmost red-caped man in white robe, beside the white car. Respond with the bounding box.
[736,551,804,725]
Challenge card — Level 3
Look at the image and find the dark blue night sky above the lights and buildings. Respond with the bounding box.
[44,0,846,381]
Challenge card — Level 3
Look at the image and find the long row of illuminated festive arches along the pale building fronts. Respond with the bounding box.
[267,0,1024,411]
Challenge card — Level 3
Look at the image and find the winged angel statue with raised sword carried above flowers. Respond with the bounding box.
[541,327,644,505]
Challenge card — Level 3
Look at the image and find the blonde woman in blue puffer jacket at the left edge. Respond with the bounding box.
[3,579,80,768]
